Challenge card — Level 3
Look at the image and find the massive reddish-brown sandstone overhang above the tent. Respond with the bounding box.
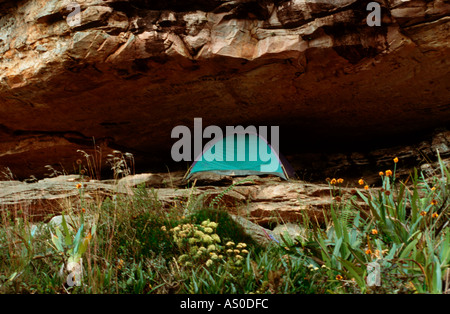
[0,0,450,177]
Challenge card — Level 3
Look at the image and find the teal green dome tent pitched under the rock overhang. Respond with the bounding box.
[187,133,294,180]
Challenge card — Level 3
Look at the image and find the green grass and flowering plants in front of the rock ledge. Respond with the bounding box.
[0,155,450,294]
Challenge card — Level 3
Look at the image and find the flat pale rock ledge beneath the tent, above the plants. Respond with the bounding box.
[0,173,366,225]
